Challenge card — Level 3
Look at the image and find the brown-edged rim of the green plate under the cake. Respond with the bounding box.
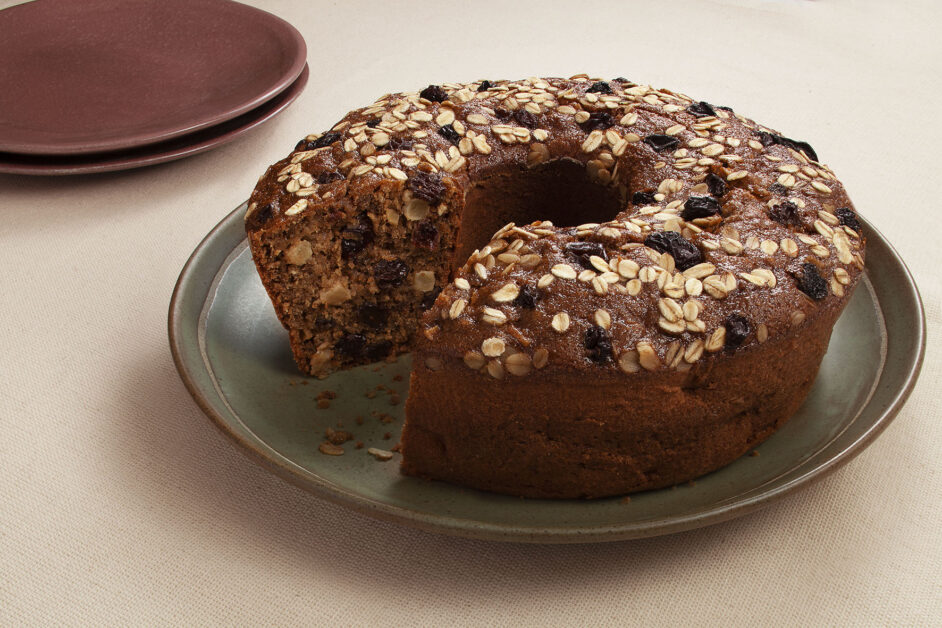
[167,203,926,544]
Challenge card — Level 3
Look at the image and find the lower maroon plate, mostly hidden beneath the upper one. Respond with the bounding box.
[0,65,309,175]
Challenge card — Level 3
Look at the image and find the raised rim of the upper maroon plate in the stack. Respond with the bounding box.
[0,0,307,158]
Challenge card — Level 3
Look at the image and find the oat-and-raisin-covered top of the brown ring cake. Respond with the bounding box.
[246,75,863,379]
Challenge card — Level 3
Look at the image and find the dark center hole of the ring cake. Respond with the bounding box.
[455,159,627,266]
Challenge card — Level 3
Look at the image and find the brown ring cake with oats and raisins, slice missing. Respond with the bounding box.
[246,76,865,498]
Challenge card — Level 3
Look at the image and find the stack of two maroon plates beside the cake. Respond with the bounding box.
[0,0,308,175]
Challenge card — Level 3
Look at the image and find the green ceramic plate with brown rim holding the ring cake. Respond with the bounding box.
[169,205,925,543]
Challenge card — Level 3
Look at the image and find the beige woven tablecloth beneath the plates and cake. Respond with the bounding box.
[0,0,942,626]
